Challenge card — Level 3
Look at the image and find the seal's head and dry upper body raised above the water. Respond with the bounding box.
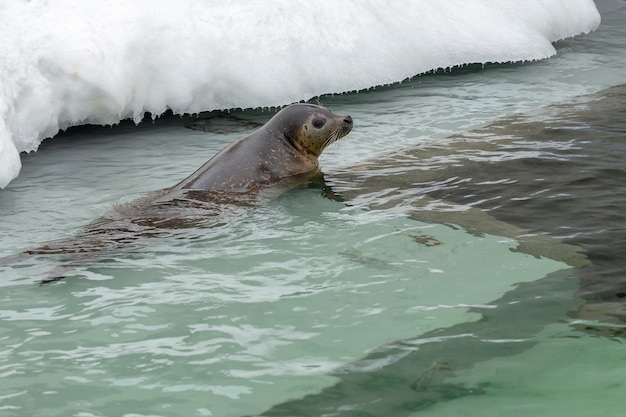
[172,103,353,192]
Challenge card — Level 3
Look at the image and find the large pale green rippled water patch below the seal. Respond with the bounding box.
[0,190,567,416]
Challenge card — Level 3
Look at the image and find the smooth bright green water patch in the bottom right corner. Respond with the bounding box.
[415,323,626,417]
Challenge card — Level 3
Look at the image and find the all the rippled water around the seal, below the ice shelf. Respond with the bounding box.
[0,5,626,416]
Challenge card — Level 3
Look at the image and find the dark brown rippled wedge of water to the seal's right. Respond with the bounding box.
[327,85,626,324]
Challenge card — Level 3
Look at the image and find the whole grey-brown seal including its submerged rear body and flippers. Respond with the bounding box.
[0,103,353,276]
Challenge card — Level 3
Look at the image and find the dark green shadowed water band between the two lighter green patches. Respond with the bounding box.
[262,272,579,417]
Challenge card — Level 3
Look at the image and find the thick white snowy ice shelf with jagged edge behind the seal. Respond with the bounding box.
[0,0,600,187]
